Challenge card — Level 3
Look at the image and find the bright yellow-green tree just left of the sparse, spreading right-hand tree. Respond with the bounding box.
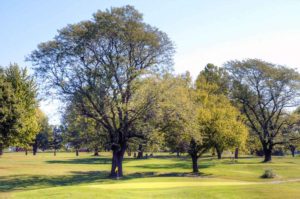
[198,94,248,159]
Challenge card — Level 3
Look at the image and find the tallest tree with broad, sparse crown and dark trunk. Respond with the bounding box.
[29,6,174,177]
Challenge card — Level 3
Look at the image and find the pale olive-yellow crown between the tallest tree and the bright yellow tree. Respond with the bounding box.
[133,74,197,159]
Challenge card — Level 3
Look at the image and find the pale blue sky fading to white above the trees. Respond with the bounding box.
[0,0,300,124]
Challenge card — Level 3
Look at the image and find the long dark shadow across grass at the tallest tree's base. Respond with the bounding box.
[0,171,210,192]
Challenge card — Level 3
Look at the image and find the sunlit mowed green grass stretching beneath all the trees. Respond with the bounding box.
[0,153,300,199]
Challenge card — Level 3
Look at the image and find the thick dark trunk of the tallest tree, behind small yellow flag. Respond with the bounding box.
[110,143,126,178]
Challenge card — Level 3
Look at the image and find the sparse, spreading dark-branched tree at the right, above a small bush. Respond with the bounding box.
[225,59,300,162]
